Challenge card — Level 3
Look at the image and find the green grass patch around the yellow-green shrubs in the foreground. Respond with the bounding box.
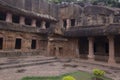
[22,71,112,80]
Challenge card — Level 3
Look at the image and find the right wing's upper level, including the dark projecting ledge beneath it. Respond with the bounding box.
[59,4,120,37]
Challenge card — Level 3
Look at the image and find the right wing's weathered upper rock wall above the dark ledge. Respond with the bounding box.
[59,4,120,29]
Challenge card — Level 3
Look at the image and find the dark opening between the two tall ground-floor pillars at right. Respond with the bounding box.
[94,36,109,62]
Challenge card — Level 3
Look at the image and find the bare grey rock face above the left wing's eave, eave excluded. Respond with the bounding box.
[2,0,58,17]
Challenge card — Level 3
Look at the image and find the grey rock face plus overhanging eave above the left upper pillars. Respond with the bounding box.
[0,0,57,21]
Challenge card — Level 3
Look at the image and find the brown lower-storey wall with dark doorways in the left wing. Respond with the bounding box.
[0,30,47,57]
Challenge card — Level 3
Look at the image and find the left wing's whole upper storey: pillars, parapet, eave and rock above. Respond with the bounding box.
[0,0,57,33]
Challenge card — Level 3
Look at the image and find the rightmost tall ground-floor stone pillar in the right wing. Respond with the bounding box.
[108,36,116,64]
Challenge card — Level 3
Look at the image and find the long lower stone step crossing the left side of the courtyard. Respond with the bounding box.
[0,59,58,70]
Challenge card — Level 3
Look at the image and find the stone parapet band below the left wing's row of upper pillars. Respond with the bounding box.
[0,21,49,34]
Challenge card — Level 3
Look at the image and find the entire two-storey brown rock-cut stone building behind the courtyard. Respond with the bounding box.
[0,0,120,64]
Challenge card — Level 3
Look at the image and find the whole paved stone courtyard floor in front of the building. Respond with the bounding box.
[0,56,120,80]
